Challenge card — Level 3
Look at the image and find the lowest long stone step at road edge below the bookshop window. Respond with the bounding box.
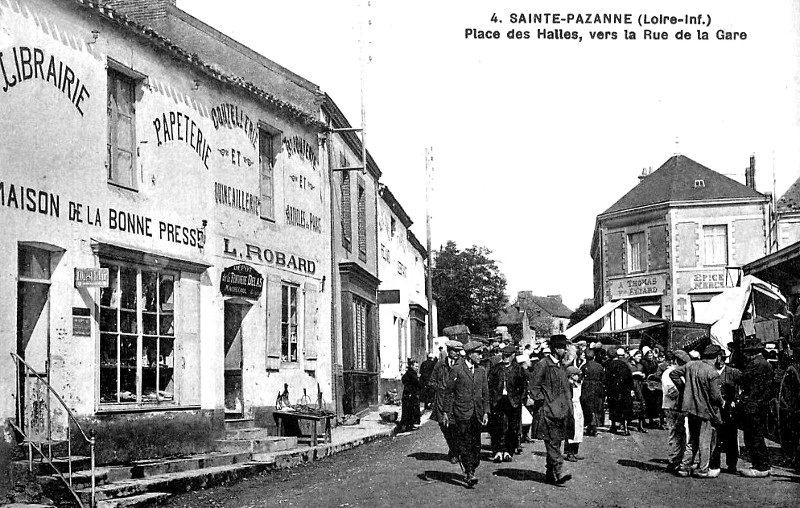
[76,462,273,503]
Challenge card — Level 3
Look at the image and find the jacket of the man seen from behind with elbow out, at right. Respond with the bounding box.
[669,360,722,425]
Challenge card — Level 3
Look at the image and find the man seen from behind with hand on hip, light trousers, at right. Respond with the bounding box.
[669,344,722,478]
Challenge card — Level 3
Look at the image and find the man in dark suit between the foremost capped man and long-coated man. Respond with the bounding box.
[488,346,528,462]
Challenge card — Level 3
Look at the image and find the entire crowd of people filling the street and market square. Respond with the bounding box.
[400,335,800,487]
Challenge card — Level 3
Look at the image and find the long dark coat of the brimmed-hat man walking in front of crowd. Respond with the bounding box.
[530,357,575,441]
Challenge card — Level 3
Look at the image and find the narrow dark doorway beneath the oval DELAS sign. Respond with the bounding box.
[225,301,250,419]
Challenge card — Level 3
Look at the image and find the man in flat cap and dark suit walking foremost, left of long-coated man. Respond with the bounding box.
[442,341,490,488]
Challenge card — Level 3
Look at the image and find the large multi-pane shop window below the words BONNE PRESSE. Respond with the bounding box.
[100,262,177,405]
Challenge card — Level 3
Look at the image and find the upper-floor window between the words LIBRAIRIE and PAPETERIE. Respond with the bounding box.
[106,68,137,189]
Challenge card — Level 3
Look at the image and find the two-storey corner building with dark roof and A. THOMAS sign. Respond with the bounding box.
[591,155,769,321]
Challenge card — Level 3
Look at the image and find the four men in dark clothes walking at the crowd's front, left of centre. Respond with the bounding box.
[431,335,575,487]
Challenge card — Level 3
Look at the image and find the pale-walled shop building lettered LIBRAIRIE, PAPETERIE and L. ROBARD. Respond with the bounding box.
[0,0,333,436]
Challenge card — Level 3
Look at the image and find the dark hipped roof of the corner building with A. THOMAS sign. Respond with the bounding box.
[600,155,766,215]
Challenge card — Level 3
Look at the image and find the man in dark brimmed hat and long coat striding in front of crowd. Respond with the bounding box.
[531,334,575,485]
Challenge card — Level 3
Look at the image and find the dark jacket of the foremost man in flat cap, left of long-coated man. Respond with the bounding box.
[443,360,490,421]
